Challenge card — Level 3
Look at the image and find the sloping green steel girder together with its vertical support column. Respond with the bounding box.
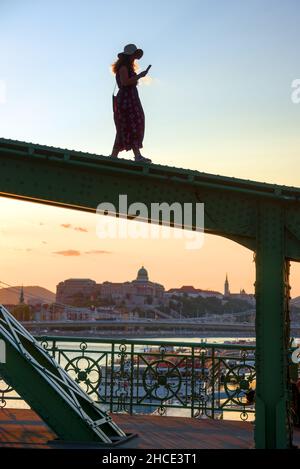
[0,139,300,448]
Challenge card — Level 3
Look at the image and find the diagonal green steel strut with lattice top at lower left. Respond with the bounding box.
[0,306,127,446]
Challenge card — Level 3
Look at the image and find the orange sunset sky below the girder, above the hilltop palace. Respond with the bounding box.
[0,198,300,297]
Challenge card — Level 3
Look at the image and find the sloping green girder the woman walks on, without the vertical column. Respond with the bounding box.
[0,135,300,261]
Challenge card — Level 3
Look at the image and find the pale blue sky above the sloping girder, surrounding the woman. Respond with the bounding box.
[0,0,300,185]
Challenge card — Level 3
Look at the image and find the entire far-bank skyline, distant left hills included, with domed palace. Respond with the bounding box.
[0,266,300,323]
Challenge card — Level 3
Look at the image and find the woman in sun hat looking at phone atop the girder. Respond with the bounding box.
[110,44,151,163]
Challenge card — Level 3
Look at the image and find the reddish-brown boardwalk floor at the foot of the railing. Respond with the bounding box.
[0,409,300,449]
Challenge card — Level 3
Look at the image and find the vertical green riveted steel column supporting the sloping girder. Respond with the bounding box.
[255,202,291,448]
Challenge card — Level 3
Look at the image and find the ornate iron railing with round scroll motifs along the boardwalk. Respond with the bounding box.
[0,337,256,420]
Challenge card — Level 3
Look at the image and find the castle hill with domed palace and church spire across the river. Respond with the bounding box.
[56,266,255,319]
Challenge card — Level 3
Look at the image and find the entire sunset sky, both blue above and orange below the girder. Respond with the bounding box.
[0,0,300,297]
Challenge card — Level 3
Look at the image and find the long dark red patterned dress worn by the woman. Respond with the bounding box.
[114,64,145,151]
